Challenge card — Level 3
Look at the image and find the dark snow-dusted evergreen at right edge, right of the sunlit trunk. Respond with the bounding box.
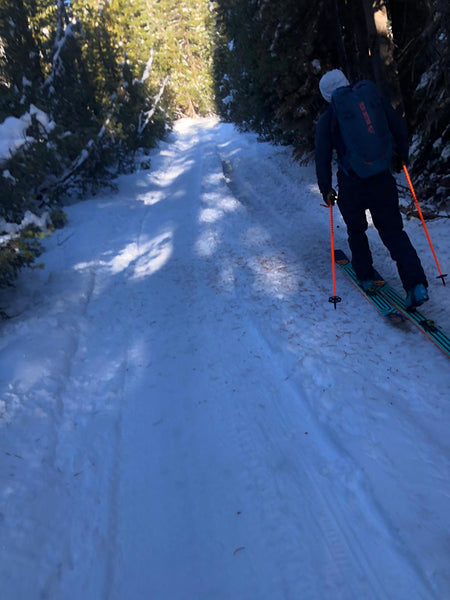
[388,0,450,212]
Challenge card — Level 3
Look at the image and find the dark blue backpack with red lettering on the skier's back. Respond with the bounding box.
[331,81,392,179]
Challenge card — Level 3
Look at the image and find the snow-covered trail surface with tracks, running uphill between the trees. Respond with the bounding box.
[0,119,450,600]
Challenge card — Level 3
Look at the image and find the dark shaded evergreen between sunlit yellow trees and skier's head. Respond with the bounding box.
[216,0,335,149]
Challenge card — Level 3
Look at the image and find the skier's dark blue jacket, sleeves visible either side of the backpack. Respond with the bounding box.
[316,94,408,194]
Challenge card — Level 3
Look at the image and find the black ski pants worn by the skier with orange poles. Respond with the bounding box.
[338,171,428,291]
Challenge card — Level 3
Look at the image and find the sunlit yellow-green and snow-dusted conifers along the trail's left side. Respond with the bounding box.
[0,0,214,287]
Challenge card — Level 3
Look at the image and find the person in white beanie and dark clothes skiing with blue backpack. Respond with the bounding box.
[315,69,428,308]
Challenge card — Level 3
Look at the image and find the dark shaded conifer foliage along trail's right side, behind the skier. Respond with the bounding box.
[215,0,450,206]
